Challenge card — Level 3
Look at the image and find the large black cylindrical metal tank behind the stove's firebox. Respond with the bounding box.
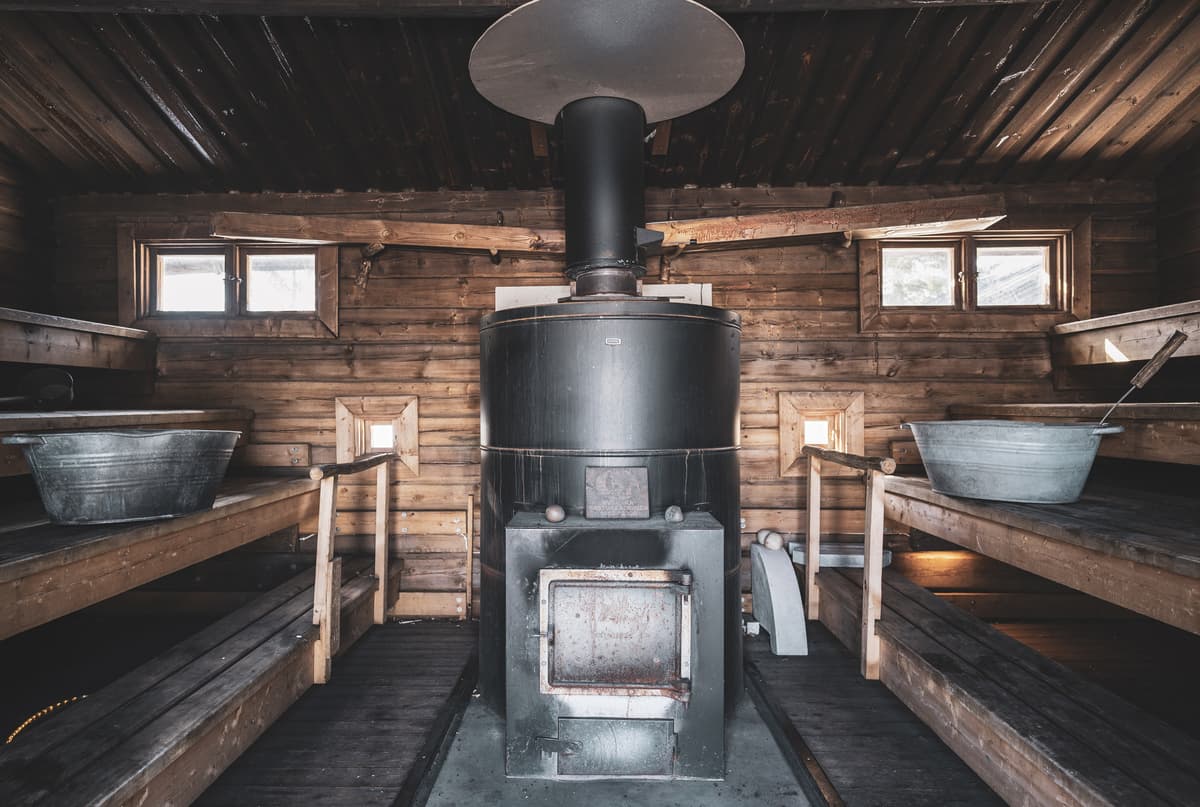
[479,299,742,711]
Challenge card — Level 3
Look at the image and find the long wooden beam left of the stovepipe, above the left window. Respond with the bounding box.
[211,213,566,255]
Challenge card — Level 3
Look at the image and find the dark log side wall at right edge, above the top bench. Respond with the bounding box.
[1158,145,1200,304]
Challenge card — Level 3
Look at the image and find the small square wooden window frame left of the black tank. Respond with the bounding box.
[334,395,421,479]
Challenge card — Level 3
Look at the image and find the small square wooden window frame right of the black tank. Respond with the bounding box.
[779,389,866,477]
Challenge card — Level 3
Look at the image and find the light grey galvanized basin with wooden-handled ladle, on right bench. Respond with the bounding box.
[904,420,1123,504]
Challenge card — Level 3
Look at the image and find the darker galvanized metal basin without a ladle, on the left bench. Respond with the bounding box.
[2,429,241,524]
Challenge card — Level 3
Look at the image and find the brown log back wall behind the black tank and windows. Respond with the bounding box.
[55,184,1157,598]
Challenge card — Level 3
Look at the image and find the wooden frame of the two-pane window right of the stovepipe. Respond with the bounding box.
[858,219,1092,334]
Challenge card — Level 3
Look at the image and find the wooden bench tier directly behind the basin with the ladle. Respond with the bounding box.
[945,403,1200,465]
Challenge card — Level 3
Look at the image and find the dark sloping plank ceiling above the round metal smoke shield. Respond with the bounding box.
[0,0,1200,192]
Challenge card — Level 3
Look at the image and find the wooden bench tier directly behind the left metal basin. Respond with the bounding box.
[0,410,252,477]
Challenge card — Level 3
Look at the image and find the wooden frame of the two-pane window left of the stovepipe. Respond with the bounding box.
[116,225,338,339]
